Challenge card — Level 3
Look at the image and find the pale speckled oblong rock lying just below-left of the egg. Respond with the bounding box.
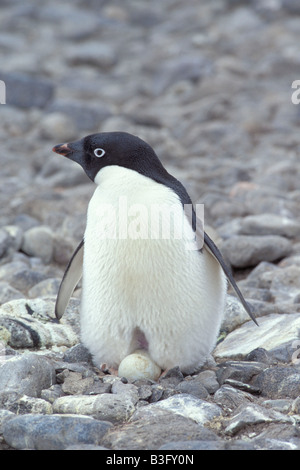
[53,393,135,423]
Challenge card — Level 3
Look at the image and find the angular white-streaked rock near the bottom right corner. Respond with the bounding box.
[225,403,291,436]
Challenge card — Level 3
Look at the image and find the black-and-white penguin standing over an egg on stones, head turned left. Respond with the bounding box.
[53,132,256,373]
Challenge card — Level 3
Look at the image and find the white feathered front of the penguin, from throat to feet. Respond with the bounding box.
[80,166,226,372]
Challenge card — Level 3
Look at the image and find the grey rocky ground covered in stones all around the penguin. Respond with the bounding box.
[0,0,300,450]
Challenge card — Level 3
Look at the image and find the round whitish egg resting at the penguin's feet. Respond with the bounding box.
[118,349,161,380]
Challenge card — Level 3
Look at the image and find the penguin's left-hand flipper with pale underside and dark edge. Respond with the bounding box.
[55,240,84,320]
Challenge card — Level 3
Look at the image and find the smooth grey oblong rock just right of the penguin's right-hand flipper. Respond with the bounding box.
[220,235,292,268]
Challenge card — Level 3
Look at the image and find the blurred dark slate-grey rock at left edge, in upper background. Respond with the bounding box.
[1,72,54,109]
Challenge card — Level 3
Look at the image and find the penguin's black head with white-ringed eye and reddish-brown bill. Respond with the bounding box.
[52,132,166,185]
